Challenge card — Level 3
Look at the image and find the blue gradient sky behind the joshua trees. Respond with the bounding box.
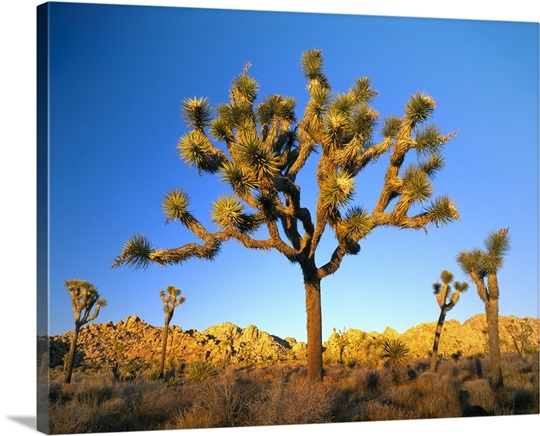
[44,3,539,340]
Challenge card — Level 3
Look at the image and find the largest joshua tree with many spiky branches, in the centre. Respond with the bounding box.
[113,50,459,380]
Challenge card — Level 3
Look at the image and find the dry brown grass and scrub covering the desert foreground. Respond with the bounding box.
[49,355,539,434]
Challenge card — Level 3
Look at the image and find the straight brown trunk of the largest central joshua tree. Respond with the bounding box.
[304,278,323,381]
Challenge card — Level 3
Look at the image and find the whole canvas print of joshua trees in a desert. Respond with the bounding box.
[37,2,539,434]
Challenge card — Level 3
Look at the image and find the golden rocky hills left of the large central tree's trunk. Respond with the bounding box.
[43,316,306,370]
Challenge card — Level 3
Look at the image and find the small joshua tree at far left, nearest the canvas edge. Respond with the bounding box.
[64,279,107,383]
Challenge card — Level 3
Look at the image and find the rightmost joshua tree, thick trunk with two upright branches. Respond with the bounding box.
[457,228,510,391]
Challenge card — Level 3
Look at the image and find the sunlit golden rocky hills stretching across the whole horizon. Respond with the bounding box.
[43,315,539,371]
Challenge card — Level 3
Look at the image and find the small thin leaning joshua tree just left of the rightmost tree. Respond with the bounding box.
[430,270,469,372]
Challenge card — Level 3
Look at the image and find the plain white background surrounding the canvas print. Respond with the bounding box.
[0,0,540,436]
